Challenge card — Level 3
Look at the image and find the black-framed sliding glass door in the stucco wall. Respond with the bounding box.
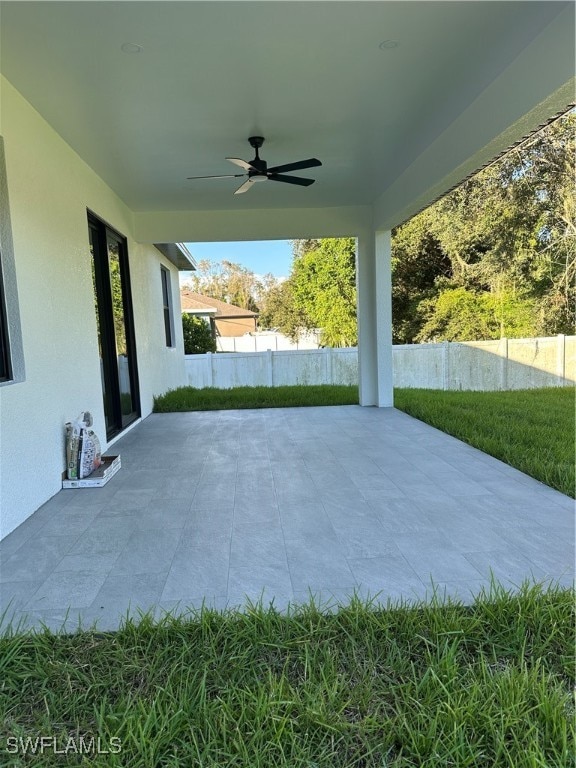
[88,213,140,439]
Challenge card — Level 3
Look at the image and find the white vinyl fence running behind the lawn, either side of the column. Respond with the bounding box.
[185,335,576,391]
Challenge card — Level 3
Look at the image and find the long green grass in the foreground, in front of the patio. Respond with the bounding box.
[0,585,575,768]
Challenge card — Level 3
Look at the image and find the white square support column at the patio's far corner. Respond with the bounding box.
[357,231,394,408]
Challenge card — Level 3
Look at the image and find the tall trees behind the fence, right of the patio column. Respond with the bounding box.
[392,114,576,342]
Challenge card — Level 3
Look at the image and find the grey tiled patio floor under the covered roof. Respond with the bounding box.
[0,406,574,631]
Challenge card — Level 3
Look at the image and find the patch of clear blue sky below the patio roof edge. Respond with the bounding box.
[180,240,292,282]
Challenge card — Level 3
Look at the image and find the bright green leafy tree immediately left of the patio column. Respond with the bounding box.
[290,237,358,347]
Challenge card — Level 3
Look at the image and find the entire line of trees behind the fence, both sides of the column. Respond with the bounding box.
[183,113,576,346]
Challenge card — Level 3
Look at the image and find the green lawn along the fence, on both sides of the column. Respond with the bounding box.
[154,386,575,497]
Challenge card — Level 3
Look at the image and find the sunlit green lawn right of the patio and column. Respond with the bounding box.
[395,388,576,497]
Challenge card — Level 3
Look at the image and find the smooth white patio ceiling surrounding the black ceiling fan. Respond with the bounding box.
[0,0,574,228]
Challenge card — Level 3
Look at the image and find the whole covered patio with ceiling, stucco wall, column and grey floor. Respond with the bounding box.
[0,0,574,544]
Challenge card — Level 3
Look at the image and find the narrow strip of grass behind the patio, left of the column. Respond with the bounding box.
[154,384,358,413]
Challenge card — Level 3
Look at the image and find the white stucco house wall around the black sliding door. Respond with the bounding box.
[0,79,186,537]
